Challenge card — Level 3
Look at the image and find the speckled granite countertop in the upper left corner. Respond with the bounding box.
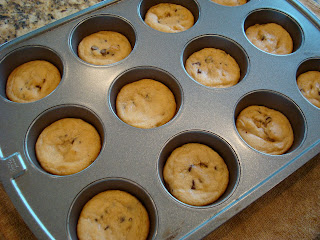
[0,0,102,44]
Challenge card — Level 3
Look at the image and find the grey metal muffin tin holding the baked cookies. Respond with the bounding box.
[0,0,320,239]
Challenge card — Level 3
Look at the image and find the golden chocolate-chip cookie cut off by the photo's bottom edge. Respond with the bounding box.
[77,190,150,240]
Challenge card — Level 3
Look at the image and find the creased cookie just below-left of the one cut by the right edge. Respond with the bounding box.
[236,105,294,155]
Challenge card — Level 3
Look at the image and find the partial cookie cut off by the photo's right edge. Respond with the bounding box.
[297,71,320,108]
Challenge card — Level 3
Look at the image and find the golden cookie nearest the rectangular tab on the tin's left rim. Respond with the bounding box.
[35,118,101,175]
